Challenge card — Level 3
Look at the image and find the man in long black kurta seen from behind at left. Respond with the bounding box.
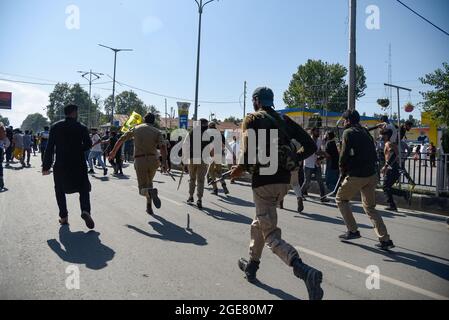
[42,105,95,229]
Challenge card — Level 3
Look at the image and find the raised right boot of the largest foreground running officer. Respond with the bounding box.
[292,258,324,300]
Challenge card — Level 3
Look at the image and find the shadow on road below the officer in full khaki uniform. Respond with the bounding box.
[126,216,207,246]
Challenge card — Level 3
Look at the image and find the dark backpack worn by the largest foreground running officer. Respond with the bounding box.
[266,113,301,172]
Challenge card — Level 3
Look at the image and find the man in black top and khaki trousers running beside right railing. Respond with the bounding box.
[336,110,394,250]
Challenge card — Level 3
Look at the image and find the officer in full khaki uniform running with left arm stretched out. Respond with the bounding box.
[108,113,167,216]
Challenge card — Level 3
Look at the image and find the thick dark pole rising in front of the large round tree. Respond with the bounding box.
[348,0,357,110]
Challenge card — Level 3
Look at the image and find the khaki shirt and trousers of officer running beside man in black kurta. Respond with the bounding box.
[121,123,164,204]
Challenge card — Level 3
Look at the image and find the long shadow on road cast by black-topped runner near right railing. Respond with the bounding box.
[344,241,449,280]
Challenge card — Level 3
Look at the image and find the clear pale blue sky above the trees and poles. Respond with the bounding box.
[0,0,449,126]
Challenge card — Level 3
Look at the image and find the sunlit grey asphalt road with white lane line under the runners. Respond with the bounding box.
[0,157,449,300]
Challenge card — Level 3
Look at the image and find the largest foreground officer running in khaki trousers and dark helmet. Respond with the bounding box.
[231,87,323,300]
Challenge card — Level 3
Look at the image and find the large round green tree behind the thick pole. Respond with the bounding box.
[284,60,367,112]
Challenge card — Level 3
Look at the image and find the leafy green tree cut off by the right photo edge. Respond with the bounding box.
[419,62,449,126]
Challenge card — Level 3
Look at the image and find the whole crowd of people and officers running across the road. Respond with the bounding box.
[0,87,440,300]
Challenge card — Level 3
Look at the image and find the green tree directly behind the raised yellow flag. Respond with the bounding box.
[104,91,149,116]
